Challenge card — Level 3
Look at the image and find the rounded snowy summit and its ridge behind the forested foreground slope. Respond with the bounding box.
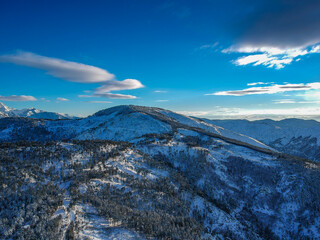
[0,105,277,156]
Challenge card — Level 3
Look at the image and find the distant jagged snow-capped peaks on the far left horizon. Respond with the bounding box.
[0,102,75,120]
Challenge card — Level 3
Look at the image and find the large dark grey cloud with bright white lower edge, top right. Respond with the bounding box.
[223,0,320,69]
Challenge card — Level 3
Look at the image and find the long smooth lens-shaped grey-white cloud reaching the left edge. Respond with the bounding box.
[0,52,115,83]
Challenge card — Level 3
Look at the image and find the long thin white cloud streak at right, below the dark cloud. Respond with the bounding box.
[205,82,320,96]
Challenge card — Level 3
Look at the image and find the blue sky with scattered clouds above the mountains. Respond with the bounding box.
[0,0,320,118]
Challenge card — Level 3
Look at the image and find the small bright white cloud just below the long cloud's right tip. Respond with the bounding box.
[95,79,144,93]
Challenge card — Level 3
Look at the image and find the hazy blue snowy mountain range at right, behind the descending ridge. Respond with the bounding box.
[203,119,320,162]
